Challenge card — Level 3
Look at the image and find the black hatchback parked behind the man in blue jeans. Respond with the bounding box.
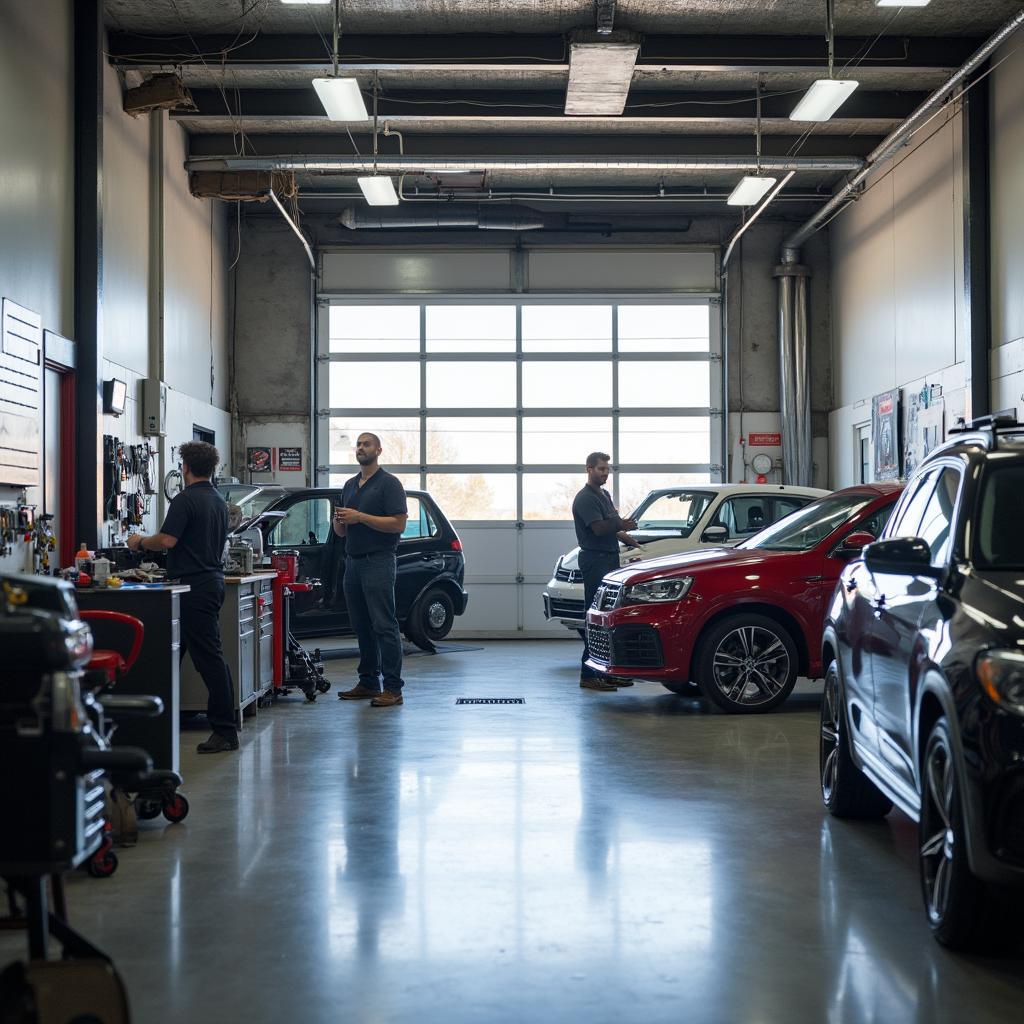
[239,487,468,650]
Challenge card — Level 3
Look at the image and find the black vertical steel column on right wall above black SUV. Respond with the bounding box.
[962,78,992,418]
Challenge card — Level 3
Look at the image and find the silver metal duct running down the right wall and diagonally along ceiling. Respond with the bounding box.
[775,10,1024,485]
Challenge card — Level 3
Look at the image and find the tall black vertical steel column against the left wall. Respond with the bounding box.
[74,0,104,548]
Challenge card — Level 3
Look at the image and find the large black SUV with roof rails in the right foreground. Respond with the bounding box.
[820,415,1024,949]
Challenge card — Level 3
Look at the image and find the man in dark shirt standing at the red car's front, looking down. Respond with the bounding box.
[572,452,640,690]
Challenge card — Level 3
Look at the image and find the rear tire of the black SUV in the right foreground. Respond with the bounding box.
[818,662,893,820]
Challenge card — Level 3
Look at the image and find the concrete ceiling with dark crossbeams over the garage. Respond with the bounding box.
[105,0,1020,226]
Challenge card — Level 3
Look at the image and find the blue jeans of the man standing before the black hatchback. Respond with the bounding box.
[344,551,404,693]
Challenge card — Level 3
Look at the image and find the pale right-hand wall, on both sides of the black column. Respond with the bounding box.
[830,36,1024,486]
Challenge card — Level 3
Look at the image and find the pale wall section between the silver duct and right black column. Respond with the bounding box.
[828,113,965,487]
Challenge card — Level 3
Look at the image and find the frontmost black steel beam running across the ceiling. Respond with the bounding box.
[109,32,979,69]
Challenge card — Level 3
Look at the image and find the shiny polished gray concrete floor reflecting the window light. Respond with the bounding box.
[0,641,1024,1024]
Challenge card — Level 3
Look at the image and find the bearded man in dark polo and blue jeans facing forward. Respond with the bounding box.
[333,433,409,708]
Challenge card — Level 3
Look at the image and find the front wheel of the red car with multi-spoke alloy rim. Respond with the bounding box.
[695,612,800,715]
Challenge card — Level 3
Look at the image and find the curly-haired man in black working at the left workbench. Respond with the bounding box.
[128,441,239,754]
